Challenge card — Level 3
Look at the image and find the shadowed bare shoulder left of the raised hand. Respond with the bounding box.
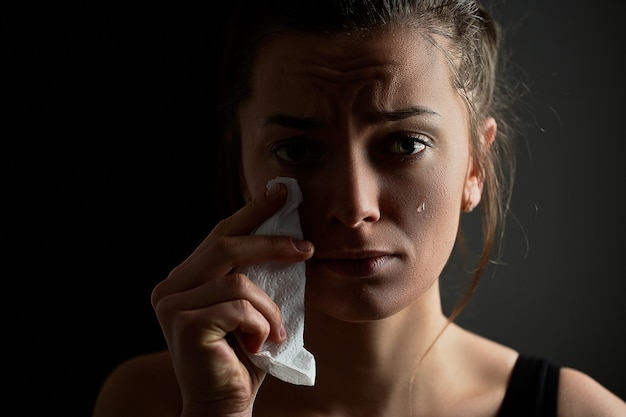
[92,351,181,417]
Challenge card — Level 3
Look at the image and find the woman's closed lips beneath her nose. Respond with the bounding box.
[313,251,396,277]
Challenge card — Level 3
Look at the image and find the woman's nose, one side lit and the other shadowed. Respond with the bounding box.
[326,152,381,228]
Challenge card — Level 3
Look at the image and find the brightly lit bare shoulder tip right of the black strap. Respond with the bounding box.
[558,368,626,417]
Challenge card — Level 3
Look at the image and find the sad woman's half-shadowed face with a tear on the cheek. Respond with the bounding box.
[239,28,480,321]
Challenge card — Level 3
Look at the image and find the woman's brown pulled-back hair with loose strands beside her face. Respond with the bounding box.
[219,0,515,321]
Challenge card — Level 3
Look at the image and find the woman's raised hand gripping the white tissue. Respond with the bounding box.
[152,184,313,417]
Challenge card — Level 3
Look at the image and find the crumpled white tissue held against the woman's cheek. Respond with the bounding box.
[242,177,315,386]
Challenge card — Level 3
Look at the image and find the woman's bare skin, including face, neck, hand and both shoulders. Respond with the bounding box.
[89,27,626,417]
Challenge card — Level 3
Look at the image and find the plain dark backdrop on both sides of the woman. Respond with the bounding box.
[0,0,626,416]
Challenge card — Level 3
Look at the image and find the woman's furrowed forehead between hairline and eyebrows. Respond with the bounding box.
[245,26,455,115]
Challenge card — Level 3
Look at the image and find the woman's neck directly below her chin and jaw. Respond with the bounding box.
[305,284,447,390]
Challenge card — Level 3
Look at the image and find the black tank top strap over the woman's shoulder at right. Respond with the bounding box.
[498,354,560,417]
